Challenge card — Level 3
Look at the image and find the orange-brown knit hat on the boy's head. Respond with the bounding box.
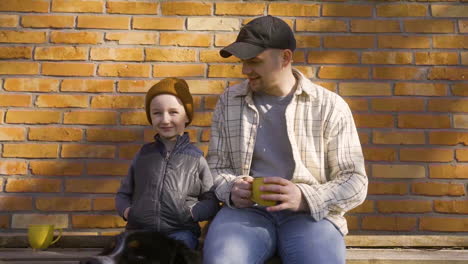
[145,78,193,126]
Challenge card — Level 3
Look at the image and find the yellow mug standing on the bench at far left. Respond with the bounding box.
[28,225,62,249]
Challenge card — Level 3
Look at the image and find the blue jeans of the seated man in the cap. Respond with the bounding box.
[203,206,346,264]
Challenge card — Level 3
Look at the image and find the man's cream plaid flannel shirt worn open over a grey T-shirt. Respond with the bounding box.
[207,69,368,235]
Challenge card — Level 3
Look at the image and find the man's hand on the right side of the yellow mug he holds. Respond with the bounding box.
[260,177,308,212]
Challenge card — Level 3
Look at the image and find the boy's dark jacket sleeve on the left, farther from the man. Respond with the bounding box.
[115,153,138,220]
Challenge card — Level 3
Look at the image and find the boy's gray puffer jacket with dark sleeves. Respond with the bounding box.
[115,133,219,235]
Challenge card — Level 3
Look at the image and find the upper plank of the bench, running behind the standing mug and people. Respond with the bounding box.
[0,233,468,249]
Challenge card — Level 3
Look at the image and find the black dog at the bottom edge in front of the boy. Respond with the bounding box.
[80,231,202,264]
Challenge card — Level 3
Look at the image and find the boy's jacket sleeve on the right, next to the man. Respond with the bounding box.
[191,156,219,222]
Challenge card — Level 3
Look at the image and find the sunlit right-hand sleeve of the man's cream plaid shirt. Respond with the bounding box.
[297,100,368,221]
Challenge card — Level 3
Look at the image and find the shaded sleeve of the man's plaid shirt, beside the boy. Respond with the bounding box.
[207,94,247,207]
